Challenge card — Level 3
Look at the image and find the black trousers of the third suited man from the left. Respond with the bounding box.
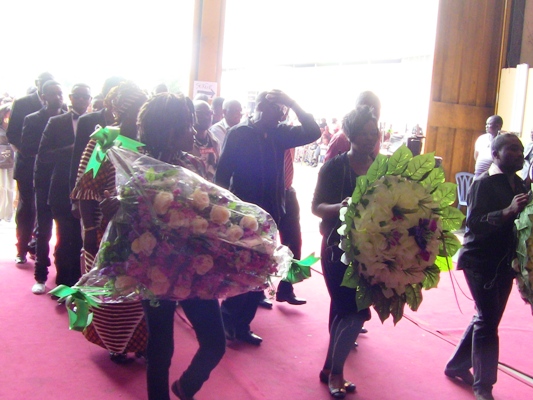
[52,208,83,286]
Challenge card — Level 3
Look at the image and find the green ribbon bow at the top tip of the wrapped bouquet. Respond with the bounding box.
[85,126,144,178]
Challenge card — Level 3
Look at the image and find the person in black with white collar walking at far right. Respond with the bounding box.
[444,134,528,400]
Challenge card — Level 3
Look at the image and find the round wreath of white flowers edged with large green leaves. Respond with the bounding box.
[338,145,465,324]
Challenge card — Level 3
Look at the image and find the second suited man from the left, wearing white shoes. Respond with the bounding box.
[19,81,65,294]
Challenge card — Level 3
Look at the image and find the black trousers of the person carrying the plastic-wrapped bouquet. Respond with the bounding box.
[142,299,226,400]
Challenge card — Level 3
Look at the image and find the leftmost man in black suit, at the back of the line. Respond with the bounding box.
[6,72,54,264]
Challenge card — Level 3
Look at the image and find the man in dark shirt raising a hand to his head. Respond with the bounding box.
[215,90,320,345]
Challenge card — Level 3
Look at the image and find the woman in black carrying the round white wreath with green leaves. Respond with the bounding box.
[312,105,379,399]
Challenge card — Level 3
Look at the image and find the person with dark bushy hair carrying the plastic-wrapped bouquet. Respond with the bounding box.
[138,93,226,400]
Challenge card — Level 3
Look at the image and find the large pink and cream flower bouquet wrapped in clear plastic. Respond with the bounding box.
[79,148,292,301]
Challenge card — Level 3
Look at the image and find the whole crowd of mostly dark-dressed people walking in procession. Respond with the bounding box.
[0,73,528,400]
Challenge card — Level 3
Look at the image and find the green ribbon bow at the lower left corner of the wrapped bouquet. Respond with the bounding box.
[50,285,102,332]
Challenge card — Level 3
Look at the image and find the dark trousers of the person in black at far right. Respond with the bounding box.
[446,269,514,390]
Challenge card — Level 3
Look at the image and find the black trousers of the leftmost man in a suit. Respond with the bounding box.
[15,177,35,255]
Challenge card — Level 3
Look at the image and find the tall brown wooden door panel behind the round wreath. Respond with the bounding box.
[424,0,510,182]
